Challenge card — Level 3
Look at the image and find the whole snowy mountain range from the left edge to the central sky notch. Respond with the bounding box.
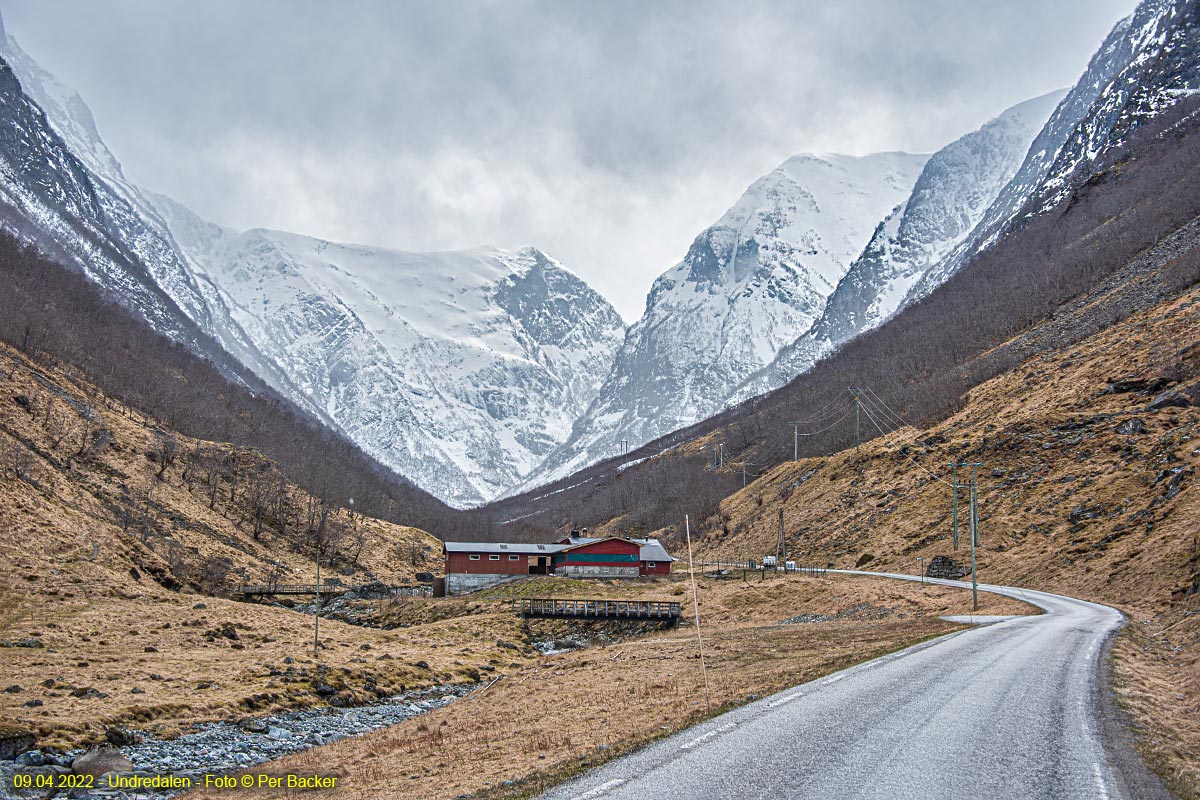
[0,31,624,505]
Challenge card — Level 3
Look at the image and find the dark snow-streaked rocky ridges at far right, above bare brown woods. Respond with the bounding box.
[736,0,1200,399]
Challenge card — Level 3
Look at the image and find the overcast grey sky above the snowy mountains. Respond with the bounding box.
[2,0,1135,321]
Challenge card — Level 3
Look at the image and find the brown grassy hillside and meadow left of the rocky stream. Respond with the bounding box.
[0,344,530,746]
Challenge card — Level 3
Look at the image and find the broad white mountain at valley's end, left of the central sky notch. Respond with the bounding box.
[155,197,624,506]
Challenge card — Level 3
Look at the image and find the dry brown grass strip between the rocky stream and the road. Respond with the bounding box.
[190,576,1030,799]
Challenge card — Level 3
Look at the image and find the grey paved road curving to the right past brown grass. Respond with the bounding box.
[542,576,1140,800]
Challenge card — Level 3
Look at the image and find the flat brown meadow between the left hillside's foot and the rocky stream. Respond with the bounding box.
[0,587,535,747]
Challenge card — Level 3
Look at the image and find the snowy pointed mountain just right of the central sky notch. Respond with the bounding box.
[526,152,928,486]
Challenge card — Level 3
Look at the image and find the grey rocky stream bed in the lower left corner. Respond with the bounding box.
[0,685,475,800]
